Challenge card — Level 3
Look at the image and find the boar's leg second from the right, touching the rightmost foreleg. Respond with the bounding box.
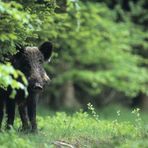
[18,101,29,130]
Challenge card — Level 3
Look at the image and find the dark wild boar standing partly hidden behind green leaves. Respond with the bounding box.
[0,42,52,131]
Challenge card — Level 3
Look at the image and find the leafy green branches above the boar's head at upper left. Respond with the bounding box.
[0,0,54,55]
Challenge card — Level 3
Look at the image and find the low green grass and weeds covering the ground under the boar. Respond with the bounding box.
[0,104,148,148]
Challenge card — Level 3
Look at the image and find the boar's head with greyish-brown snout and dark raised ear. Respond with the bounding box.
[13,42,52,90]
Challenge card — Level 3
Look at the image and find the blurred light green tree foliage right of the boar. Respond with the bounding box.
[47,2,148,96]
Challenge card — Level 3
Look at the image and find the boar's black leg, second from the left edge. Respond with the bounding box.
[6,99,15,129]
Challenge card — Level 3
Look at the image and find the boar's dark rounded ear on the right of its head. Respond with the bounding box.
[39,42,52,61]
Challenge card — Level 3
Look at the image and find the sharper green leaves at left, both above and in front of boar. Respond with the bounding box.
[0,1,53,91]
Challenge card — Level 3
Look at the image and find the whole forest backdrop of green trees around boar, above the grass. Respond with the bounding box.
[0,0,148,110]
